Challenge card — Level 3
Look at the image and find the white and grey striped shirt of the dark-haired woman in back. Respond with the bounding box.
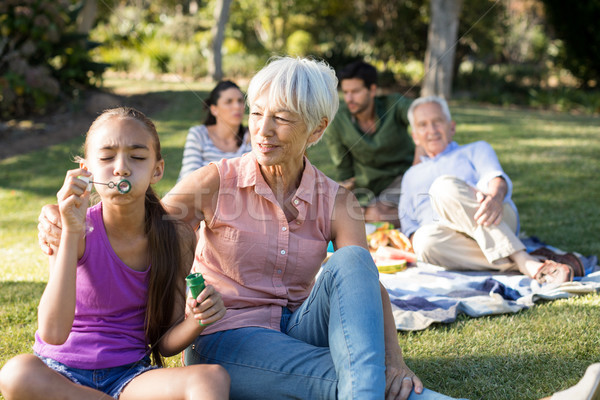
[177,125,252,181]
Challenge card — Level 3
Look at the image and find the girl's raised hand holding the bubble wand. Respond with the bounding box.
[56,168,91,233]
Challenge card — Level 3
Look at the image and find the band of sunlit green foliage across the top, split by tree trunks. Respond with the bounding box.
[82,0,600,112]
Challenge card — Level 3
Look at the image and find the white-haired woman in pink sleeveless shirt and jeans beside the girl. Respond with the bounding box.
[38,57,460,400]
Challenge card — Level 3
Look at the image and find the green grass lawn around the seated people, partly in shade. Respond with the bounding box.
[0,81,600,400]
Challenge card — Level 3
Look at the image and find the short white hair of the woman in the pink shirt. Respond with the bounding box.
[247,57,340,144]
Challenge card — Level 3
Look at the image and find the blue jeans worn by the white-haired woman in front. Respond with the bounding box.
[185,246,458,400]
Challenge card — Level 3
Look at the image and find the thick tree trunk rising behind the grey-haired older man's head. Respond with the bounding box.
[421,0,463,99]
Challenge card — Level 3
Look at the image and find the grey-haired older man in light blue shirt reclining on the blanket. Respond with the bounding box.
[398,96,584,284]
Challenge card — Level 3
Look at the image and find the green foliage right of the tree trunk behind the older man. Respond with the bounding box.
[454,0,600,113]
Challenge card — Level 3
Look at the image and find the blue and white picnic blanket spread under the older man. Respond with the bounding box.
[380,238,600,331]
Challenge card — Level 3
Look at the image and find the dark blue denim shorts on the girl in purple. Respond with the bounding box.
[36,353,158,399]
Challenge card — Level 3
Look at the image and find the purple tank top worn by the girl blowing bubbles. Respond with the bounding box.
[33,203,150,369]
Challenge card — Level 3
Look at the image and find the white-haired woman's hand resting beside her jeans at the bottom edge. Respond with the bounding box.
[385,352,423,400]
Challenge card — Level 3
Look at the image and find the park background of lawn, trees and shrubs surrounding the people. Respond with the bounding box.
[0,0,600,399]
